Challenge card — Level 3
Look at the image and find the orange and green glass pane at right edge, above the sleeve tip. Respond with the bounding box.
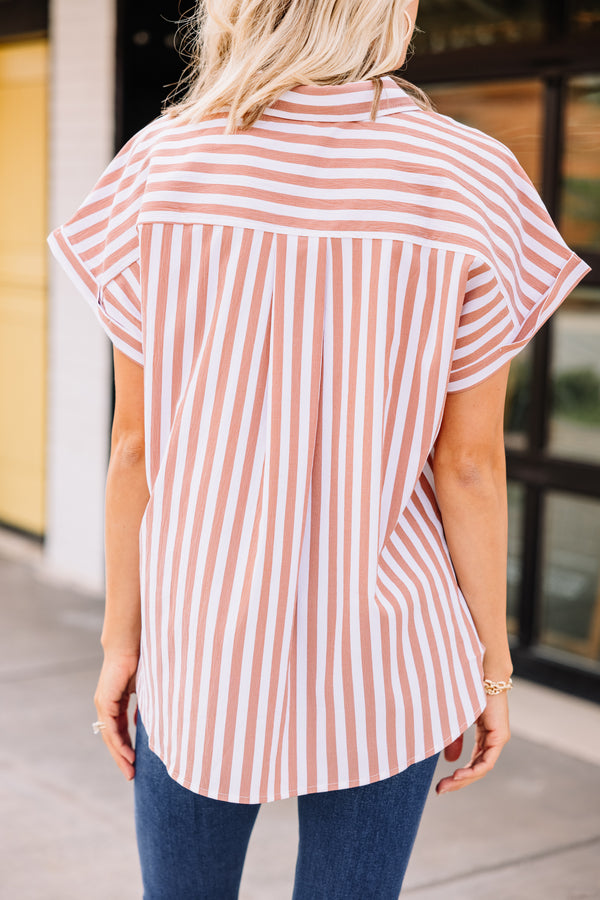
[561,75,600,252]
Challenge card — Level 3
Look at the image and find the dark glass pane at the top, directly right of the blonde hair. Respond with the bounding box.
[414,0,544,54]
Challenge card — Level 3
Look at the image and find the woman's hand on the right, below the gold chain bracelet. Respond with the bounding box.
[435,691,510,794]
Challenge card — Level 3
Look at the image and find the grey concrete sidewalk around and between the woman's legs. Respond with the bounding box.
[0,542,600,900]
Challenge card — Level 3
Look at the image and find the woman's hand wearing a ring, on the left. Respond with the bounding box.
[94,651,139,781]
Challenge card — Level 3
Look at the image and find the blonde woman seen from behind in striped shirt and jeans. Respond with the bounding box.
[50,0,588,900]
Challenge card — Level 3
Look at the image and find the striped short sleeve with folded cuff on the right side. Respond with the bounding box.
[447,147,590,392]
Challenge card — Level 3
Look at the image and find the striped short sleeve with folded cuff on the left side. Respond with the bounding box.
[48,122,162,365]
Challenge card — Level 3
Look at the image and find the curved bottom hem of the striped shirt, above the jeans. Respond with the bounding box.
[142,684,487,805]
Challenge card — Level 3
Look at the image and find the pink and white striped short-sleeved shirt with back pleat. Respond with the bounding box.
[49,76,588,803]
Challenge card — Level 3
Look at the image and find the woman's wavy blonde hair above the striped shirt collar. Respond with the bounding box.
[163,0,431,134]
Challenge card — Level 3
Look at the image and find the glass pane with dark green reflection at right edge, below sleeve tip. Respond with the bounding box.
[548,287,600,462]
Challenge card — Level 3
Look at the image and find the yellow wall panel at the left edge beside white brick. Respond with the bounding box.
[0,40,48,534]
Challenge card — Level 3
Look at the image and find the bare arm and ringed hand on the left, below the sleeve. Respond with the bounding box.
[94,347,149,780]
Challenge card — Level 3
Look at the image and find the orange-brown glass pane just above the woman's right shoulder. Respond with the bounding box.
[427,80,544,191]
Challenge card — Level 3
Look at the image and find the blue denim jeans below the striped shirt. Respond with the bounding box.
[134,710,439,900]
